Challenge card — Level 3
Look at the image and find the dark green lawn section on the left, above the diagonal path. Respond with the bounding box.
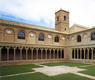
[0,64,40,76]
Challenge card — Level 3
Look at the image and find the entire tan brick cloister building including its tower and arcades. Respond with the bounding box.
[0,10,95,65]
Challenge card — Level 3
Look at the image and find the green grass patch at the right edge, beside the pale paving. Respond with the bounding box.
[80,65,95,76]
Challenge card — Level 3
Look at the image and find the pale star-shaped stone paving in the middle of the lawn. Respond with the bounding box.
[33,66,85,76]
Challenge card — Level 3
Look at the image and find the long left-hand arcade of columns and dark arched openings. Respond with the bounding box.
[0,46,64,61]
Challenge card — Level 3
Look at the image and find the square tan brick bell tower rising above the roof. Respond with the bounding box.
[55,9,69,33]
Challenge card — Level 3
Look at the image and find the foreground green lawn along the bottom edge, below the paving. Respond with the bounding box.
[0,72,92,80]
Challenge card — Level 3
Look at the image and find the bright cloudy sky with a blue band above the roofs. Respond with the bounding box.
[0,0,95,28]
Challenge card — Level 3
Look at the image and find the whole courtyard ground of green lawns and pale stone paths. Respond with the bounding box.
[0,62,95,80]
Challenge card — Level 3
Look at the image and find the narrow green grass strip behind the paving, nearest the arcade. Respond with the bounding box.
[42,62,88,67]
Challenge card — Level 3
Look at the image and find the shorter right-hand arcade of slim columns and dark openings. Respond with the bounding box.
[72,48,95,60]
